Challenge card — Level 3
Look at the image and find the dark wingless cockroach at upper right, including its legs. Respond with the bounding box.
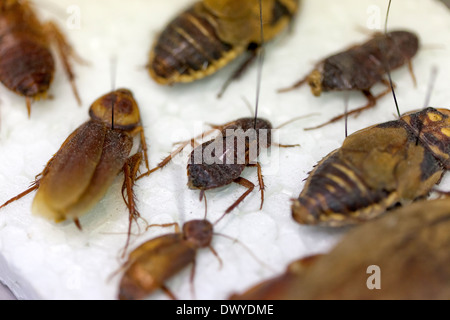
[280,31,419,130]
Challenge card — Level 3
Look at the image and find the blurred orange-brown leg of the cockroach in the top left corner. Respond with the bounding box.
[44,21,86,106]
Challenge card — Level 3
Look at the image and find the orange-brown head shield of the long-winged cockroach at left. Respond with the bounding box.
[89,89,141,130]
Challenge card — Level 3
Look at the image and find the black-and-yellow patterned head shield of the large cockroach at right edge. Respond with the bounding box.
[402,108,450,169]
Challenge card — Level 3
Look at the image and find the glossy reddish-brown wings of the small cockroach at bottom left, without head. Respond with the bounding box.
[119,233,196,300]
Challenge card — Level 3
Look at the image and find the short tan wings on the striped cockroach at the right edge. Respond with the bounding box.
[339,121,444,202]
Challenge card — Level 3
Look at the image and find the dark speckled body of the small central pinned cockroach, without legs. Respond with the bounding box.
[187,118,272,190]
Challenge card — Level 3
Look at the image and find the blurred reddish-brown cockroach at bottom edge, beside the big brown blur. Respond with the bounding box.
[229,254,322,300]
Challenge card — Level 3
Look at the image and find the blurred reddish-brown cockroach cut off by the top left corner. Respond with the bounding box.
[0,0,81,115]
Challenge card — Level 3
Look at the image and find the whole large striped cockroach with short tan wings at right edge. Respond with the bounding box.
[292,108,450,226]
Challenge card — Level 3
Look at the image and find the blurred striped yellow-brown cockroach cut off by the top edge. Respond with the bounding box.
[148,0,299,95]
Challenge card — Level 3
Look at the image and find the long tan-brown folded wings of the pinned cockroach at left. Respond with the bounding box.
[32,121,133,222]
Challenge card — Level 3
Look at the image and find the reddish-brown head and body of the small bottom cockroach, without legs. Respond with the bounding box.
[119,220,213,300]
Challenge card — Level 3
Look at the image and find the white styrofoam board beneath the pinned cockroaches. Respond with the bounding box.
[0,0,450,299]
